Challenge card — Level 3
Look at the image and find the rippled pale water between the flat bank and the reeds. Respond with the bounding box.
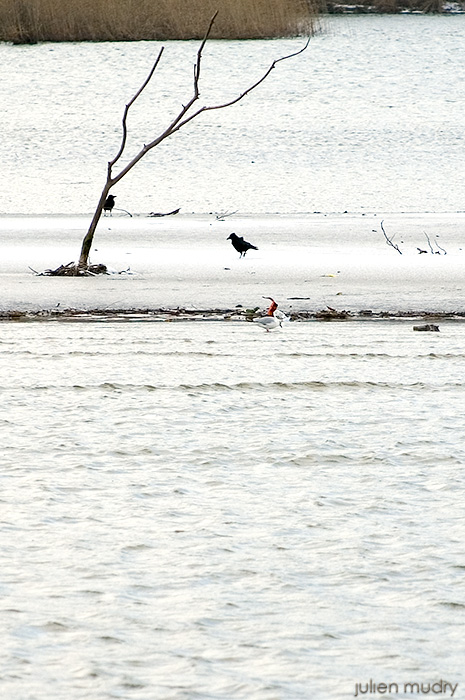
[0,15,465,214]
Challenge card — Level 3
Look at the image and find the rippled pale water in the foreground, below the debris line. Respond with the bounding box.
[0,321,465,700]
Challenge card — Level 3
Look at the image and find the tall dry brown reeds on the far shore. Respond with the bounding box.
[0,0,316,43]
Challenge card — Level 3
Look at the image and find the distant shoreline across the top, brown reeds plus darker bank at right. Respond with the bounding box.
[0,0,465,46]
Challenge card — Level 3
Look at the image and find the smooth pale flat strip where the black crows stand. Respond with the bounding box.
[0,212,465,320]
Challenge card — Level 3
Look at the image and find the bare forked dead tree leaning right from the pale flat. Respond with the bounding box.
[72,13,310,274]
